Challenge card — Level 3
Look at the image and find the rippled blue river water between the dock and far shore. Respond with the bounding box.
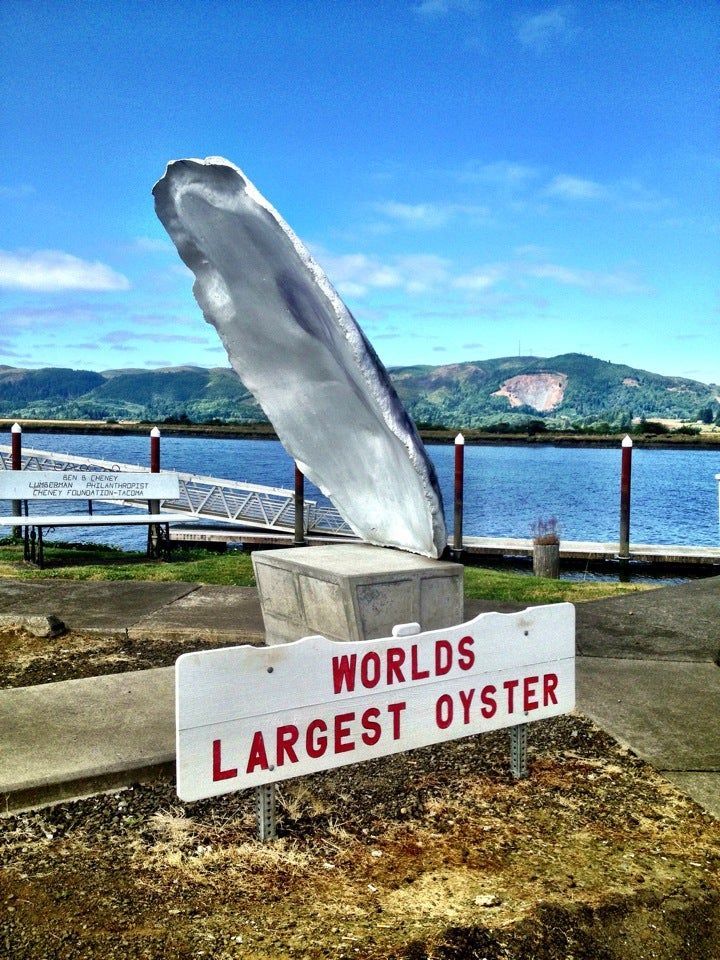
[11,431,720,548]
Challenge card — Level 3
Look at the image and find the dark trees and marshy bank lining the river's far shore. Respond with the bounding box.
[0,417,720,450]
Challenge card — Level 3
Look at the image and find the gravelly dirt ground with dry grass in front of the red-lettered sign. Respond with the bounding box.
[0,716,720,960]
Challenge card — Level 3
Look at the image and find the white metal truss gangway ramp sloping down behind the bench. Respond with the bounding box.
[0,444,354,537]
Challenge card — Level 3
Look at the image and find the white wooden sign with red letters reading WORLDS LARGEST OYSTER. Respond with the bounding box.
[175,603,575,801]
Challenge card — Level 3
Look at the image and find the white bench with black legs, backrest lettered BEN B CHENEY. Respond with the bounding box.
[0,470,188,566]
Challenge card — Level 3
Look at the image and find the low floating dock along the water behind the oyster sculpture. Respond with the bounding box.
[170,527,720,567]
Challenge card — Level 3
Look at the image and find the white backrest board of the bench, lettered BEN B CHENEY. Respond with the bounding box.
[0,470,180,501]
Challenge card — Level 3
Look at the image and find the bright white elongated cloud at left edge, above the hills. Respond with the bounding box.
[0,250,130,291]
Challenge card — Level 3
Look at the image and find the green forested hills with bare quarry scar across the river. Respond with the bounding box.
[0,353,720,428]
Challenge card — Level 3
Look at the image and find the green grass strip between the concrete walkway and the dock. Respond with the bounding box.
[0,541,649,604]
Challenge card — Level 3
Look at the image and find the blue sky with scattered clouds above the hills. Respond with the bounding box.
[0,0,720,382]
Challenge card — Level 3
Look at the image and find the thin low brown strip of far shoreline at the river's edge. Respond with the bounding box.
[0,418,720,451]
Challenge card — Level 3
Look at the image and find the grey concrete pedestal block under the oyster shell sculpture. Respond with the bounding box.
[252,544,463,644]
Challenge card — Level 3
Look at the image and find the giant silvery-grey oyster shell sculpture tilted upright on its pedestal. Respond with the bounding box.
[153,157,447,557]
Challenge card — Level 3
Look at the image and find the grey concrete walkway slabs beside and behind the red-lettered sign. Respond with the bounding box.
[0,577,720,817]
